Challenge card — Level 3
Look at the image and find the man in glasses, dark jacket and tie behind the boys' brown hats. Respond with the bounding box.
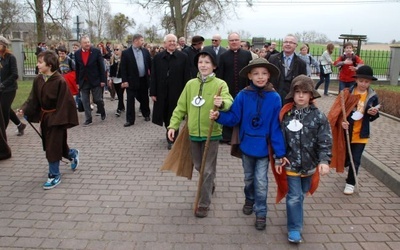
[269,34,307,103]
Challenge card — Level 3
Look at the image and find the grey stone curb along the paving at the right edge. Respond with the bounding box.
[361,151,400,197]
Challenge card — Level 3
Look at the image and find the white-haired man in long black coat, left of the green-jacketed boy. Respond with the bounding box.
[150,34,190,149]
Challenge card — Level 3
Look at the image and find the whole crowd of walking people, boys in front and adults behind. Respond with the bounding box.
[0,32,379,243]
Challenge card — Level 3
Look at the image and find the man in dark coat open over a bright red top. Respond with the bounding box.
[75,36,107,126]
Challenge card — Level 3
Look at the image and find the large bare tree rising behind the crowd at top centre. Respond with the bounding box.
[132,0,252,37]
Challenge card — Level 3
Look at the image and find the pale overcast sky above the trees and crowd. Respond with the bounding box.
[110,0,400,43]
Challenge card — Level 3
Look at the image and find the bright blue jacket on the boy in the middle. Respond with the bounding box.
[217,82,286,158]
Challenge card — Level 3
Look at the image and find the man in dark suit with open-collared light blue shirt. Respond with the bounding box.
[121,34,151,127]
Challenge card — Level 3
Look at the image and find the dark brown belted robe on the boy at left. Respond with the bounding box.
[22,72,79,162]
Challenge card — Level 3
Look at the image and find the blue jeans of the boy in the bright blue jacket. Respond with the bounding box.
[242,154,269,217]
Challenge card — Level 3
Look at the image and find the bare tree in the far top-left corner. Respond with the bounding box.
[0,0,22,34]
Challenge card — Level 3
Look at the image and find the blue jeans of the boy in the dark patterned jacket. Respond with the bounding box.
[286,176,312,232]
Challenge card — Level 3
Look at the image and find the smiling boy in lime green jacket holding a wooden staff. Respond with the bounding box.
[168,51,233,218]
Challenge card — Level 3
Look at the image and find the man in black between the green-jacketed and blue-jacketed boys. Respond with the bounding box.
[217,32,252,143]
